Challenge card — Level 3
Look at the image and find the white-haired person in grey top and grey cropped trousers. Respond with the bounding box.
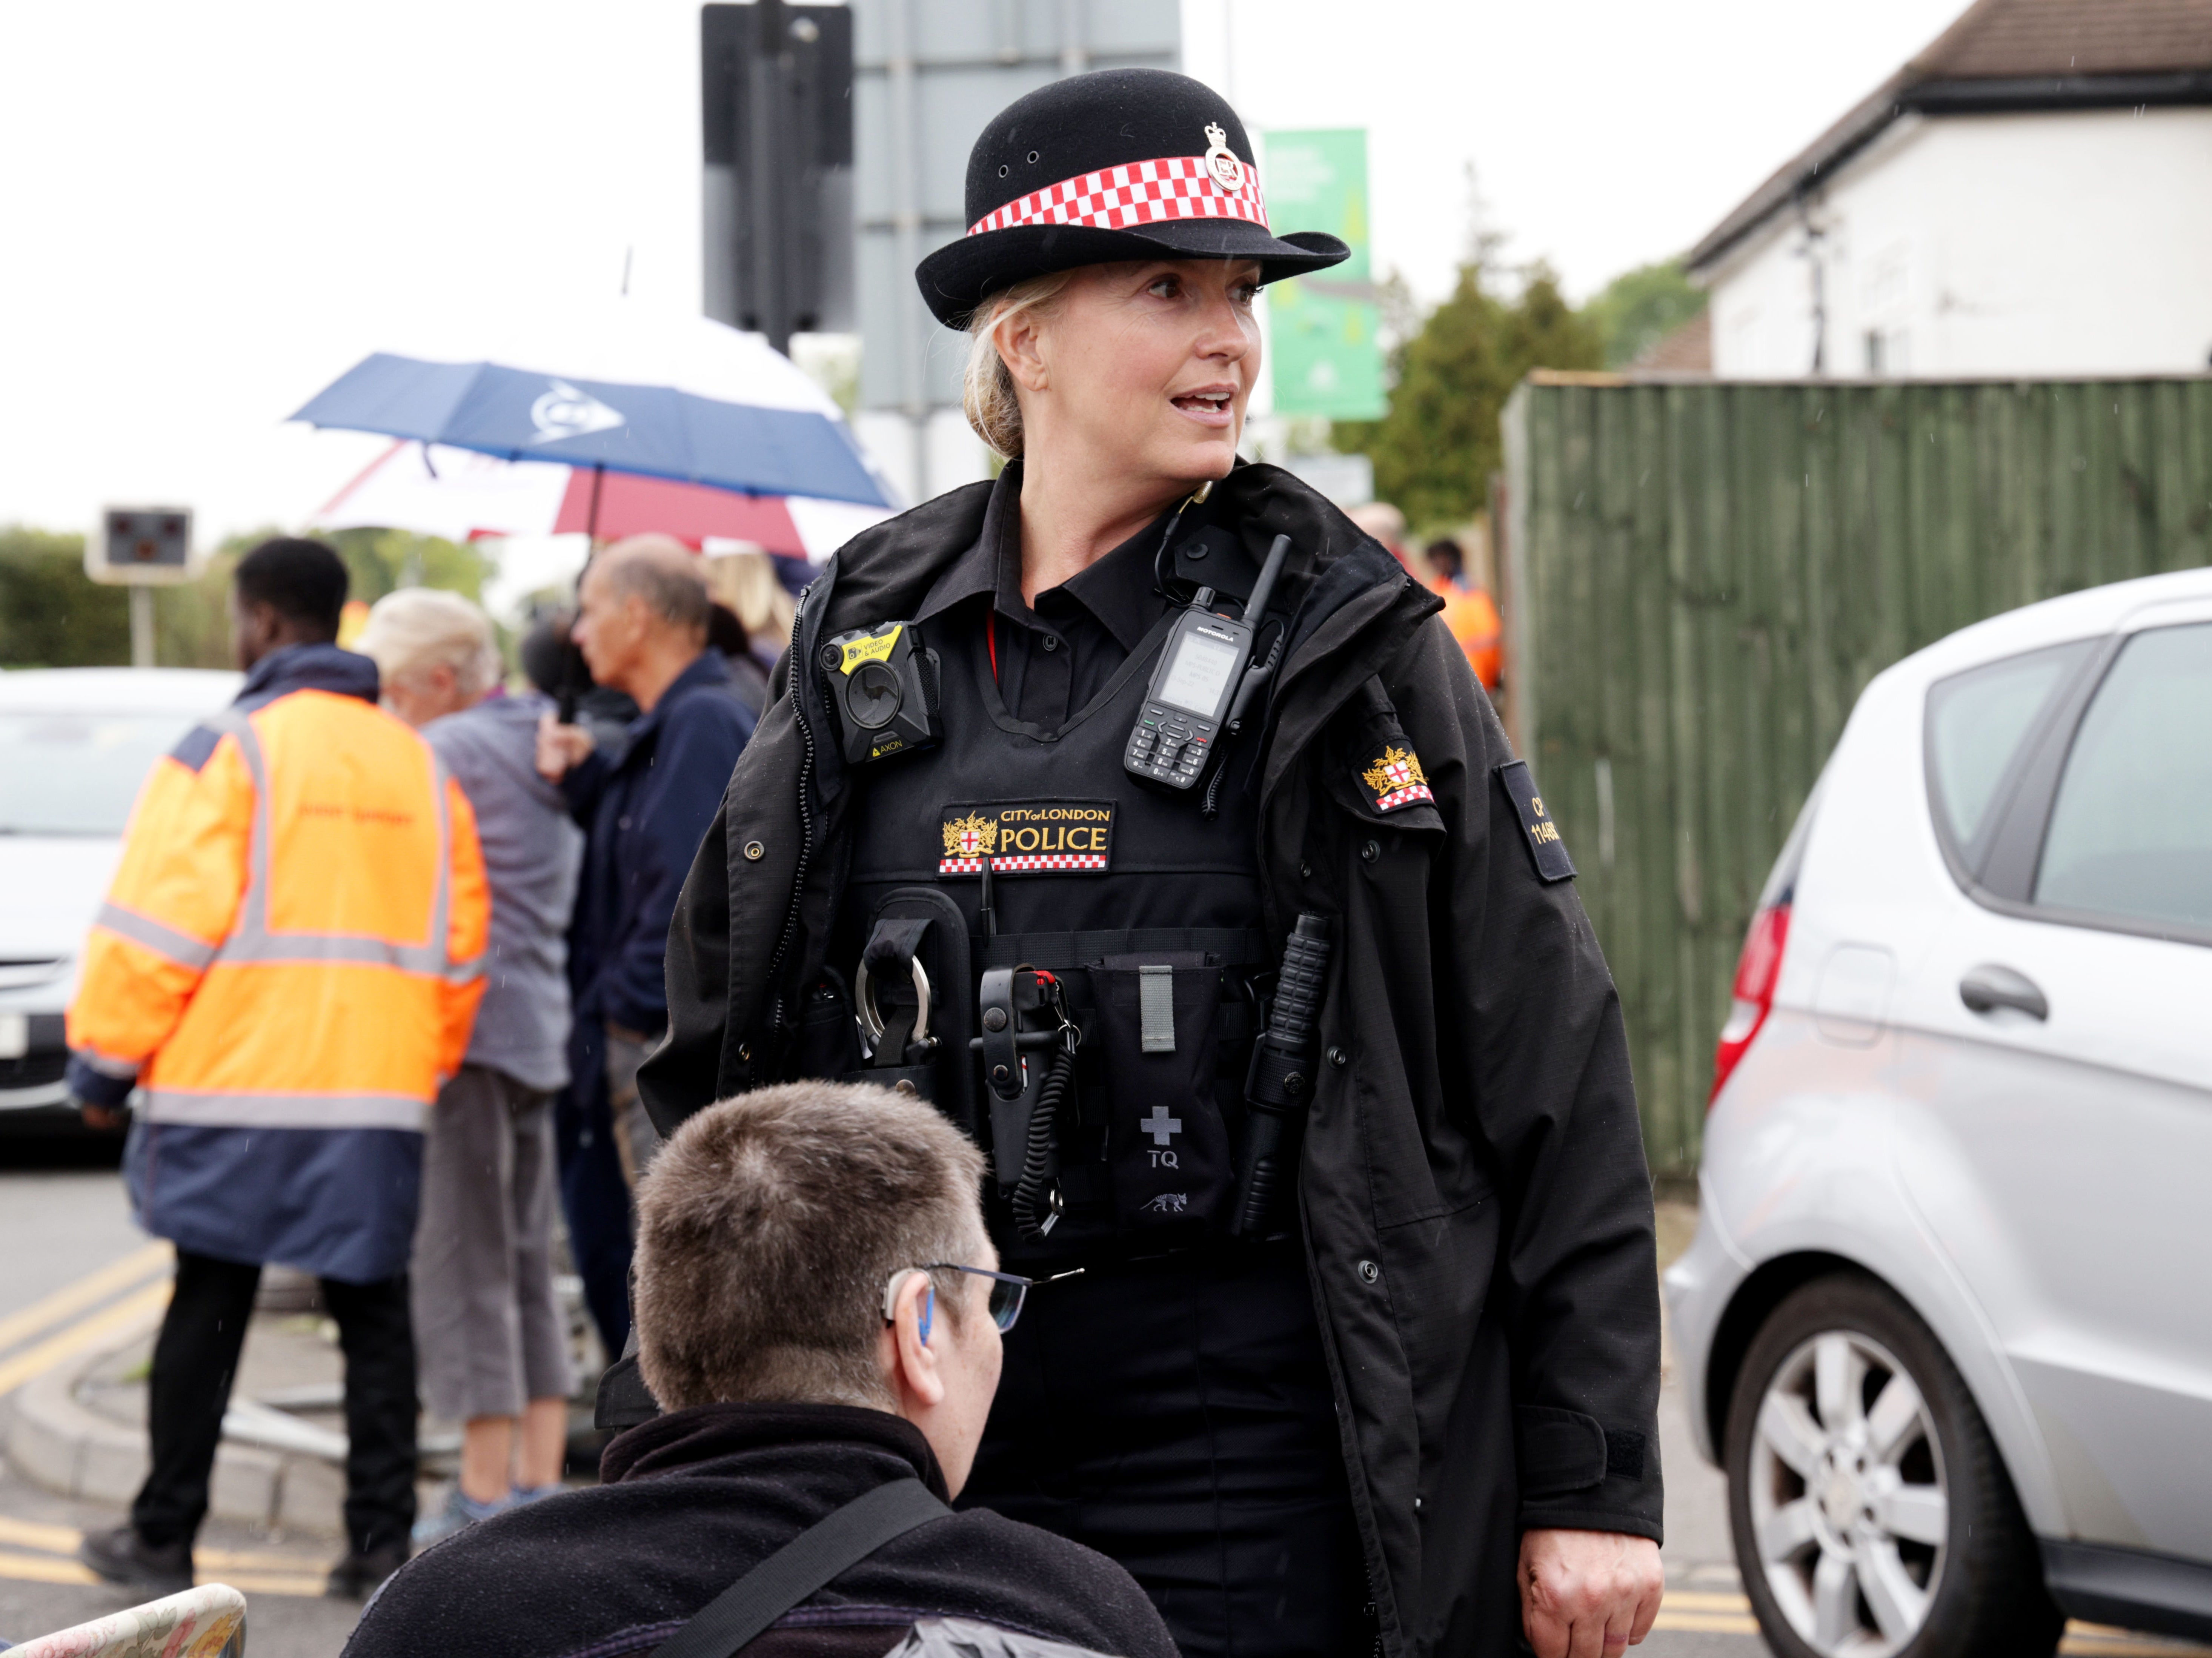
[361,588,584,1545]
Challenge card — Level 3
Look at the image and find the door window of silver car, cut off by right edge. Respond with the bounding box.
[2035,624,2212,928]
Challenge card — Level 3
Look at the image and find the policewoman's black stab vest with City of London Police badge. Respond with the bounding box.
[827,606,1267,1271]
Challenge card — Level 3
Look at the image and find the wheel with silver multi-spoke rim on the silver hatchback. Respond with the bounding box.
[1725,1273,2066,1658]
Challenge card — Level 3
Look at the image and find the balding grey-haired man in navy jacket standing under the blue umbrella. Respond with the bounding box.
[538,535,752,1353]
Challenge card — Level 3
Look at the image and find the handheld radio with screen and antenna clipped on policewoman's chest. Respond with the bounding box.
[1122,535,1290,789]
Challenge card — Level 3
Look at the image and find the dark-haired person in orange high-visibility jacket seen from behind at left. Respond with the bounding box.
[69,539,491,1596]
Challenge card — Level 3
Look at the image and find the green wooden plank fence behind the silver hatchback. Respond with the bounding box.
[1500,373,2212,1172]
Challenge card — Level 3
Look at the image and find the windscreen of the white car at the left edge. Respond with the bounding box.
[0,710,192,836]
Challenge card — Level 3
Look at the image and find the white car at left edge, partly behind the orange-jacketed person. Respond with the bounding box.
[0,668,241,1134]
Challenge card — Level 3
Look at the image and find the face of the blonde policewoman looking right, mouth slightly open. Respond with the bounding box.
[1009,259,1261,484]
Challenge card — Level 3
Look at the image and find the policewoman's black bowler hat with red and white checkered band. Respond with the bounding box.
[913,69,1351,327]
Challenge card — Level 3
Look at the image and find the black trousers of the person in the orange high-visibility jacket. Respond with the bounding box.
[131,1249,416,1554]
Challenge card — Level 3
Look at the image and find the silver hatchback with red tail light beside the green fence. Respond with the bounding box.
[1666,570,2212,1658]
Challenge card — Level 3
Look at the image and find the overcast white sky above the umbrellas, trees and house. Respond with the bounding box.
[0,0,1960,544]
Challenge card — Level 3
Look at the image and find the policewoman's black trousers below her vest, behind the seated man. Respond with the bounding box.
[960,1245,1376,1658]
